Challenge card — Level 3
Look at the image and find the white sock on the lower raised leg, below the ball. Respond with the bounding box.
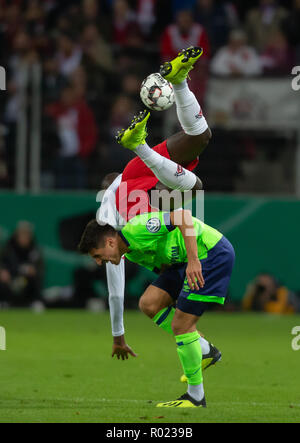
[134,144,197,191]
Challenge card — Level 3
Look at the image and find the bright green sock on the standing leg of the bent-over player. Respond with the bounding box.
[175,331,203,385]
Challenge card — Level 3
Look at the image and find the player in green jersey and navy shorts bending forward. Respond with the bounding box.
[79,210,235,408]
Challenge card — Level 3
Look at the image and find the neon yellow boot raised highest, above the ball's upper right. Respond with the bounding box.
[160,46,203,85]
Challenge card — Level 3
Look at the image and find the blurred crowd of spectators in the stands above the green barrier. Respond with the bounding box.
[0,0,300,189]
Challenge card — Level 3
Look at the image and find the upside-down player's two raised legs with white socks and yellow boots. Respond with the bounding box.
[117,47,212,186]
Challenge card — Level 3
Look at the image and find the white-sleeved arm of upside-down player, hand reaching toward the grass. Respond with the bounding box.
[106,260,136,360]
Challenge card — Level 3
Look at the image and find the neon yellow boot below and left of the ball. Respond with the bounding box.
[116,110,150,151]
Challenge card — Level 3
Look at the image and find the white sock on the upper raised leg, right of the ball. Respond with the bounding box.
[173,80,208,135]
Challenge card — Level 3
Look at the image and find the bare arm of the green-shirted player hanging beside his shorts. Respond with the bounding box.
[170,209,205,291]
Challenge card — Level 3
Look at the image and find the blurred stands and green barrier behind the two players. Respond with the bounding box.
[0,0,300,306]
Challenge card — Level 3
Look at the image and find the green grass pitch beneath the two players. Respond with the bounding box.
[0,311,300,423]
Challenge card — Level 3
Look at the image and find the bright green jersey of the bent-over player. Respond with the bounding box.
[120,212,222,272]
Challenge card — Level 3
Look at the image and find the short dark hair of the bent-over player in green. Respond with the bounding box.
[78,220,116,254]
